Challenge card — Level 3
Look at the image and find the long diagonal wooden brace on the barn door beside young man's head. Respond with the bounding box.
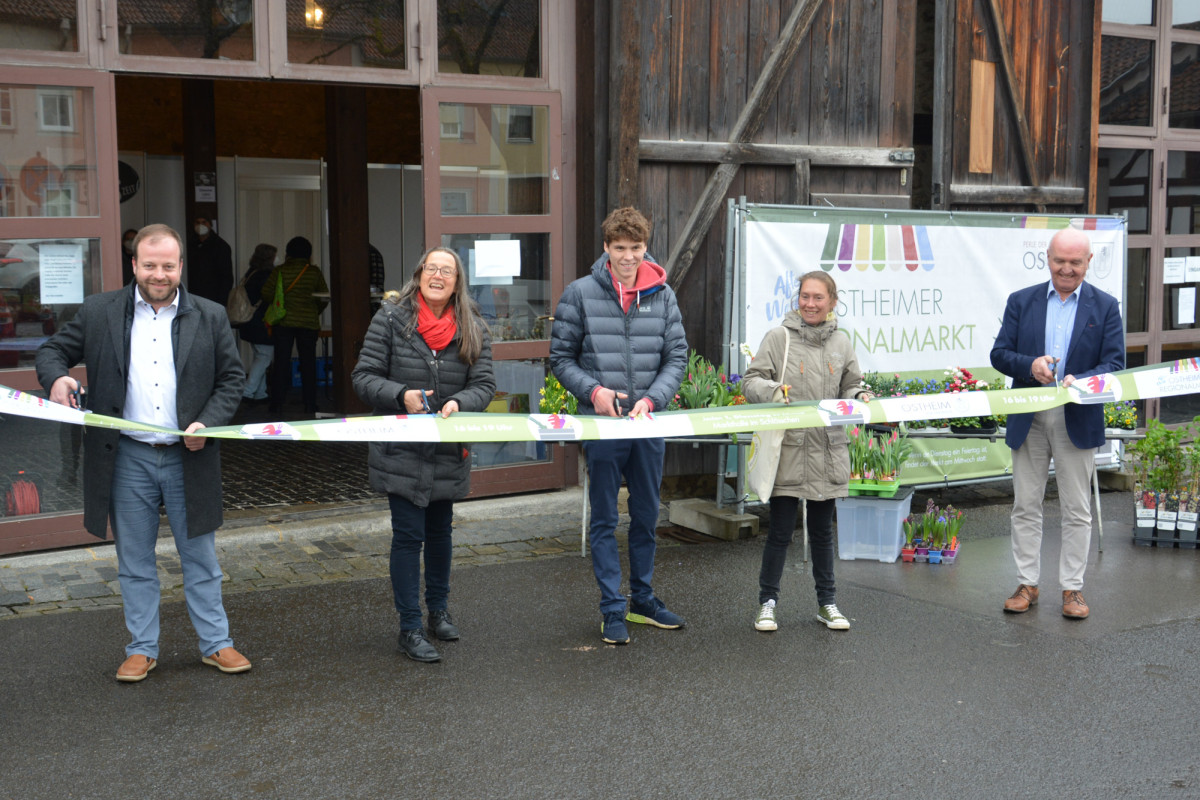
[666,0,821,289]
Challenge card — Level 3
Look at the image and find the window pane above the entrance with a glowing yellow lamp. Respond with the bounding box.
[287,0,406,70]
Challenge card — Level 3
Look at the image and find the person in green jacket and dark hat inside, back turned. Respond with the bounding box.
[262,236,329,416]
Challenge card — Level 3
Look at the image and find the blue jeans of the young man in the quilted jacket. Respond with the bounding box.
[583,439,666,614]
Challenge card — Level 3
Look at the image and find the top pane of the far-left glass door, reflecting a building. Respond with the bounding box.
[0,84,100,217]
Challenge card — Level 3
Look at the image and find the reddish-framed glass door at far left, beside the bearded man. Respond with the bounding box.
[0,67,121,553]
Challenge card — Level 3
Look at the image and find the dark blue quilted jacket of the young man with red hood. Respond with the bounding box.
[550,254,688,414]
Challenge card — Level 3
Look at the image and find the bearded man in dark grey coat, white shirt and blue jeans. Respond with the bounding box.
[37,224,250,682]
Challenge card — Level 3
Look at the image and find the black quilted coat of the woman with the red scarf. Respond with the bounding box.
[350,297,496,509]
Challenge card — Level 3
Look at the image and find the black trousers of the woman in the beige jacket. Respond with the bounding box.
[758,497,836,606]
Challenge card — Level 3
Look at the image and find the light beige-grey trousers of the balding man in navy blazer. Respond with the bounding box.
[1013,408,1096,590]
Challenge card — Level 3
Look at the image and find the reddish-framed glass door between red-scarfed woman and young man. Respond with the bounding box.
[422,88,576,497]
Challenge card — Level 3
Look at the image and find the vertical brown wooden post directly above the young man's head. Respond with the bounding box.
[608,0,642,210]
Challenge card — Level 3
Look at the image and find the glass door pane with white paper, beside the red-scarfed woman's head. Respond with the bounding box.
[442,234,550,342]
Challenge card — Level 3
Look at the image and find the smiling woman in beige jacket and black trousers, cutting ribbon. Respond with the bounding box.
[742,271,874,631]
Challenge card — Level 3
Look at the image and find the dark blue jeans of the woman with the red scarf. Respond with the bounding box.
[388,494,454,631]
